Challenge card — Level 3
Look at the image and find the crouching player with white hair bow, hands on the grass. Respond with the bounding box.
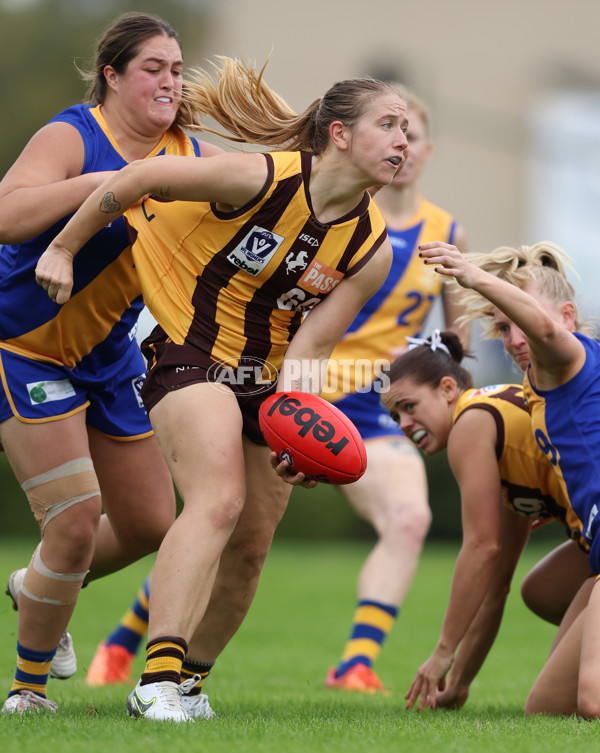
[382,330,585,710]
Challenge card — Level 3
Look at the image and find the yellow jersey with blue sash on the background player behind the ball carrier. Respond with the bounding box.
[323,197,456,402]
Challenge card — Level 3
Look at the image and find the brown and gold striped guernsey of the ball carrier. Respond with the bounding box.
[126,152,386,376]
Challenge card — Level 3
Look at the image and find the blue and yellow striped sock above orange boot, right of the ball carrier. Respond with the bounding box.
[335,599,398,678]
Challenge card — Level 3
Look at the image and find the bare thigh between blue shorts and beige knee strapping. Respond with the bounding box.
[0,410,90,483]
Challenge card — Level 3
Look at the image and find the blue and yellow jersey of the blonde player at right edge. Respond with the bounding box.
[524,332,600,572]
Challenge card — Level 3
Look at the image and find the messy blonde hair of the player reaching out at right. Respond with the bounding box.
[453,241,586,338]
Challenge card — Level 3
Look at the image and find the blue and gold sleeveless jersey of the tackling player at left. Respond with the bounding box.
[0,105,200,380]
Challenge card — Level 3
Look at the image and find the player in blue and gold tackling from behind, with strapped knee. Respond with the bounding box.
[0,13,221,713]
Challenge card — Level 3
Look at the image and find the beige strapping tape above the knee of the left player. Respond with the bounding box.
[21,458,100,535]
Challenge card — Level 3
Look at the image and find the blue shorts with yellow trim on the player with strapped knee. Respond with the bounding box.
[0,340,152,440]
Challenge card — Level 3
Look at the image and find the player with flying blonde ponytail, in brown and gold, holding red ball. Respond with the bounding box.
[36,58,407,721]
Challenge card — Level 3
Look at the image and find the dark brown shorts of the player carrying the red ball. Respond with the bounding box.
[142,340,277,445]
